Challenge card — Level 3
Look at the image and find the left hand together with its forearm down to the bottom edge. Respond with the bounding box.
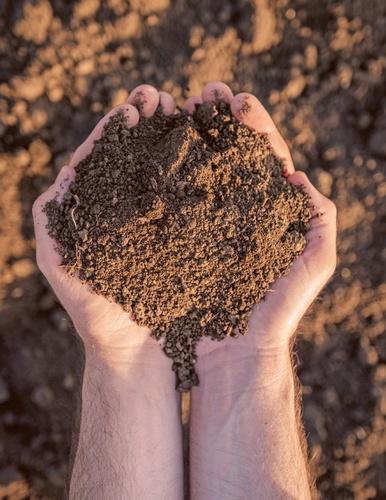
[33,85,183,499]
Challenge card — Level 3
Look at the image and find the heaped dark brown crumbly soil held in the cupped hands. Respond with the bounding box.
[46,103,311,392]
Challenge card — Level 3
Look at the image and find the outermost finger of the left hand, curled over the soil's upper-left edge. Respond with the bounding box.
[70,102,139,168]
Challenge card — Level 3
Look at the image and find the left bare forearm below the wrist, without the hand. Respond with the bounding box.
[69,346,183,500]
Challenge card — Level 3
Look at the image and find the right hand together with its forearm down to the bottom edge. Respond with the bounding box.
[185,82,328,499]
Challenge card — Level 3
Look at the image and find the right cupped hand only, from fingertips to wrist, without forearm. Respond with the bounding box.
[193,82,336,377]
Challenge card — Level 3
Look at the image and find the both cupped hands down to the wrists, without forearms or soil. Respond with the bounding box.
[33,82,336,372]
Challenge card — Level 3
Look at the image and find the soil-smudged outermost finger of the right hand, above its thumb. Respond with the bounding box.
[231,92,295,175]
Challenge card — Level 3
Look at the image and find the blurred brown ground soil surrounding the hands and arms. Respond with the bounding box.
[0,0,386,499]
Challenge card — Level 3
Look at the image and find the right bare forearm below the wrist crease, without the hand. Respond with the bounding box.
[190,346,311,500]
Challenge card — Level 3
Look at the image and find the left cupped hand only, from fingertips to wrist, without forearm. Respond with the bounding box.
[33,85,175,364]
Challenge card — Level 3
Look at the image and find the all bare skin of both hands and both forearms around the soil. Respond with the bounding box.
[33,82,336,500]
